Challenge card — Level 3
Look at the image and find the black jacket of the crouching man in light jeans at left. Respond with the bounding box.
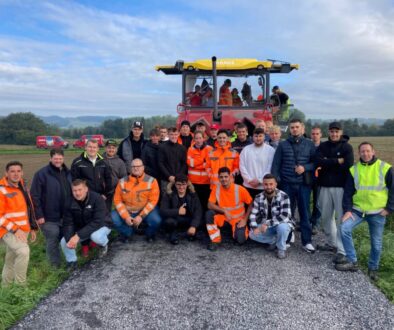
[63,191,111,242]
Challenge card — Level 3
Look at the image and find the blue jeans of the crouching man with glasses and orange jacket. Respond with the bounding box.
[111,207,161,238]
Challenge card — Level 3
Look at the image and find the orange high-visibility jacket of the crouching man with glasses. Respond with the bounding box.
[114,174,160,219]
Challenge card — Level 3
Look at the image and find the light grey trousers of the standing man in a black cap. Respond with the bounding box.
[318,187,345,255]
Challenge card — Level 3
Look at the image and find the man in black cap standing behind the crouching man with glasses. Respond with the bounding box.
[118,121,146,174]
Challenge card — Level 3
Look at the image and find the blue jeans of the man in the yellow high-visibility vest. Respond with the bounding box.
[341,212,386,270]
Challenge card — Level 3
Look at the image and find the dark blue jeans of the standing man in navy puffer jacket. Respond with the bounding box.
[280,182,312,245]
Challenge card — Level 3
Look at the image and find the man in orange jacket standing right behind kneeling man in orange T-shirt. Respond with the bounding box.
[207,129,239,188]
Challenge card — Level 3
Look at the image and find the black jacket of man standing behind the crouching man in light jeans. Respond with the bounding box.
[71,152,113,196]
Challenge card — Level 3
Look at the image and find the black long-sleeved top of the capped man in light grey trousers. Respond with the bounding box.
[315,137,354,187]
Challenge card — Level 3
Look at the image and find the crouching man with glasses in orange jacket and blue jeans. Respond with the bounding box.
[111,158,161,243]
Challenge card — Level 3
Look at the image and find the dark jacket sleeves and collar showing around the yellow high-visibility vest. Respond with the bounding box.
[342,157,394,213]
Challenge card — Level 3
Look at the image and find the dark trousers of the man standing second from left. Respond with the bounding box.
[41,221,62,266]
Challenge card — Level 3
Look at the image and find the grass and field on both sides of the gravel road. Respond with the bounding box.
[0,137,394,329]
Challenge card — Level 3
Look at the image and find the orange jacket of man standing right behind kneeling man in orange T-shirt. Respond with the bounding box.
[207,142,239,185]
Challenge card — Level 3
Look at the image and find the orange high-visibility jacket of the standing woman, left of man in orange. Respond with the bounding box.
[187,145,212,184]
